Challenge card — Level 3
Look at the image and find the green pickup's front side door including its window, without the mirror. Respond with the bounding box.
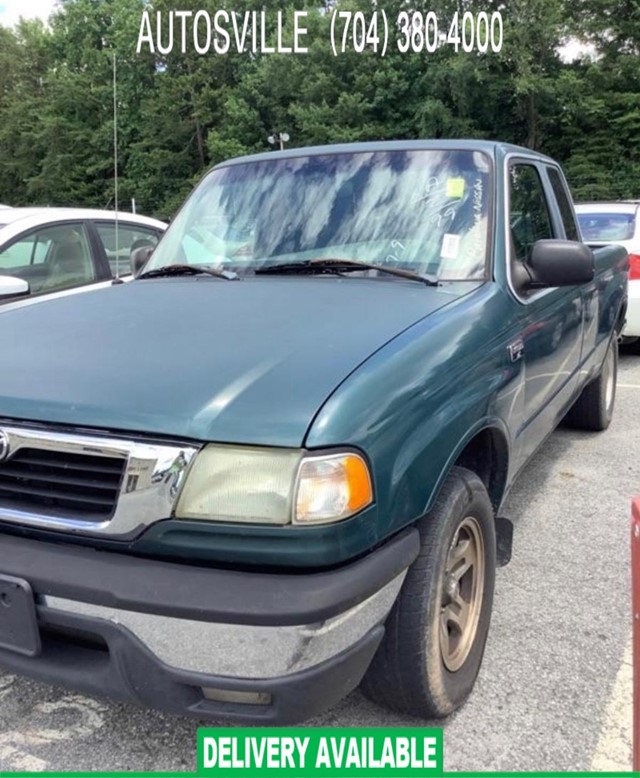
[508,159,584,457]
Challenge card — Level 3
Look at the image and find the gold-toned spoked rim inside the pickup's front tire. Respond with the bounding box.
[440,516,485,673]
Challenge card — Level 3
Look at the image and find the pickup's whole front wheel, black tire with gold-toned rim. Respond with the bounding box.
[362,467,496,718]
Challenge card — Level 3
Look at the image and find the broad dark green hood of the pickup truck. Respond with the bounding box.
[0,276,456,446]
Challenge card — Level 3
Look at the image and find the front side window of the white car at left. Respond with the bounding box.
[0,224,94,294]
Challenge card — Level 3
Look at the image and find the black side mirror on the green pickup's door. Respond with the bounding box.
[526,240,595,286]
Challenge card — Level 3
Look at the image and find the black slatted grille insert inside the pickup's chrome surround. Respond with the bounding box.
[0,448,127,522]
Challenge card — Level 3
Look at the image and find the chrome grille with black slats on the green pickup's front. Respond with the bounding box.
[0,422,199,539]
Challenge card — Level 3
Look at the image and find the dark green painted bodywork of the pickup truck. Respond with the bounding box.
[0,141,626,568]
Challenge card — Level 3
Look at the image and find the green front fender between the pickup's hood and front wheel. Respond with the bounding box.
[306,285,522,539]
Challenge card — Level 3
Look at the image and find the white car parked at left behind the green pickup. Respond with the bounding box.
[0,208,167,303]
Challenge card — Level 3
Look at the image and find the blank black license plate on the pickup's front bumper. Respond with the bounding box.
[0,575,41,656]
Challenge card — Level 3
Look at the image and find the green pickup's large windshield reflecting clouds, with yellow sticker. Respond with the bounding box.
[145,150,491,281]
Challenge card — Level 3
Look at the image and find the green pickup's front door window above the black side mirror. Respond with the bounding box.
[509,164,555,263]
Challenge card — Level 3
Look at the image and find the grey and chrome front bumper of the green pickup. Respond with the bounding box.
[0,530,419,723]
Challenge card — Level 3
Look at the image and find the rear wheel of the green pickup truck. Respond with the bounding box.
[566,335,618,432]
